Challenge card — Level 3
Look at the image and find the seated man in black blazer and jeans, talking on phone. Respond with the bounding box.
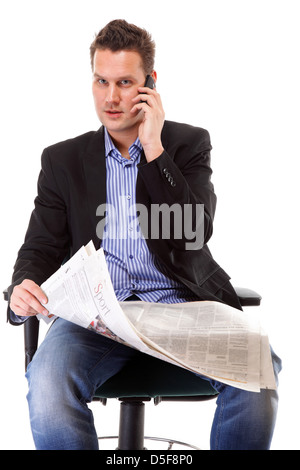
[9,20,277,449]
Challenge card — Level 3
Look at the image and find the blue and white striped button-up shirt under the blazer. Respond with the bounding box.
[102,128,197,303]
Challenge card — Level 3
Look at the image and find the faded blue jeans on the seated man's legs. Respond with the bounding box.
[26,319,280,450]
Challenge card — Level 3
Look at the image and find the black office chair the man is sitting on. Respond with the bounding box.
[4,287,261,450]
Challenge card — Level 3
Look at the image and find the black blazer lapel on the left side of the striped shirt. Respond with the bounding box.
[83,127,106,249]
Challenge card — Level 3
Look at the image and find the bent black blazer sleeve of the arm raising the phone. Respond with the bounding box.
[139,126,217,250]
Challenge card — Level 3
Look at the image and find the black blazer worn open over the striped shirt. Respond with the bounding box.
[8,121,236,323]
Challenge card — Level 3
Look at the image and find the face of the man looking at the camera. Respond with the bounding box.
[93,49,145,140]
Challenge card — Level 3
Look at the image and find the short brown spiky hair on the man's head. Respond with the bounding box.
[90,20,155,74]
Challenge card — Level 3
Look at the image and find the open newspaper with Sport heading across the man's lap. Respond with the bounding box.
[38,242,276,392]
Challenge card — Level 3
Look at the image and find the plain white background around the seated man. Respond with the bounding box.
[0,0,300,449]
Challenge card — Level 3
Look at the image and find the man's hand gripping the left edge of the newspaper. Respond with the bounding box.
[10,279,49,317]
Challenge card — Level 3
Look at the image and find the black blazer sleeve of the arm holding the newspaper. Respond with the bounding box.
[7,149,69,324]
